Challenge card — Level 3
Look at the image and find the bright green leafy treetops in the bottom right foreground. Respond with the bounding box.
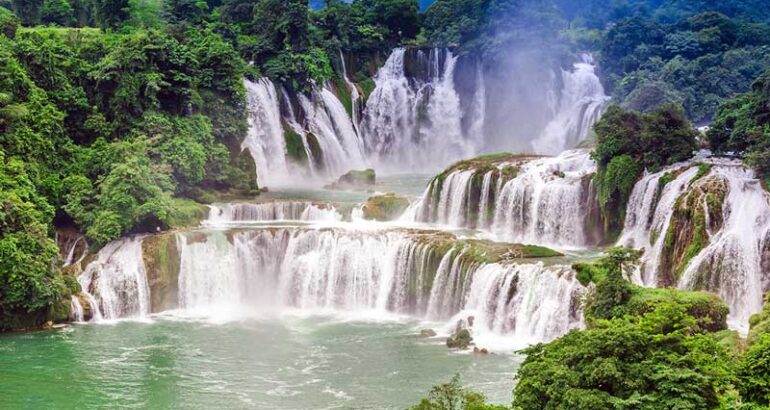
[513,302,734,410]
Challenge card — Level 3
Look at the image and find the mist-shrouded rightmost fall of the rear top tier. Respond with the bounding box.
[532,54,610,154]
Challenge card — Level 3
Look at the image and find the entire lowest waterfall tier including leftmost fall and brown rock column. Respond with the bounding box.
[80,227,584,342]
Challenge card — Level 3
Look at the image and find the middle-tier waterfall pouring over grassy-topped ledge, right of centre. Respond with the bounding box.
[404,151,598,247]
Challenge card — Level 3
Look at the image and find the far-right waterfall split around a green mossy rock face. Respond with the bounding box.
[618,159,770,332]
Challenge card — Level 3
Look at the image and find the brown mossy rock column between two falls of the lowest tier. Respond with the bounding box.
[142,232,181,312]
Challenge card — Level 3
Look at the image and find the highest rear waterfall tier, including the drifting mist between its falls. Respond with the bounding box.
[238,48,607,186]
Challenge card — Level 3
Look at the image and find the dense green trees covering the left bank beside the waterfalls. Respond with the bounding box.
[0,9,256,328]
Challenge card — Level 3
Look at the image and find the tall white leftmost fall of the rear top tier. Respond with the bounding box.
[242,78,290,186]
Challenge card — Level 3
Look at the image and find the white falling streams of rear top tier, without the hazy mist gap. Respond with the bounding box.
[238,48,608,179]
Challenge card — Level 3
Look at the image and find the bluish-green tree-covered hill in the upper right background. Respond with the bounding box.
[599,11,770,123]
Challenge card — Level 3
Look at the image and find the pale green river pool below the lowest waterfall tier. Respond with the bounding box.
[0,312,521,409]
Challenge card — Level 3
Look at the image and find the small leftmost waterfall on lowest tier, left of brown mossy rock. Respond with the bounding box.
[78,237,150,319]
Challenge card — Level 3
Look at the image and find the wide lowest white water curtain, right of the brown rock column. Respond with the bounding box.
[172,228,582,334]
